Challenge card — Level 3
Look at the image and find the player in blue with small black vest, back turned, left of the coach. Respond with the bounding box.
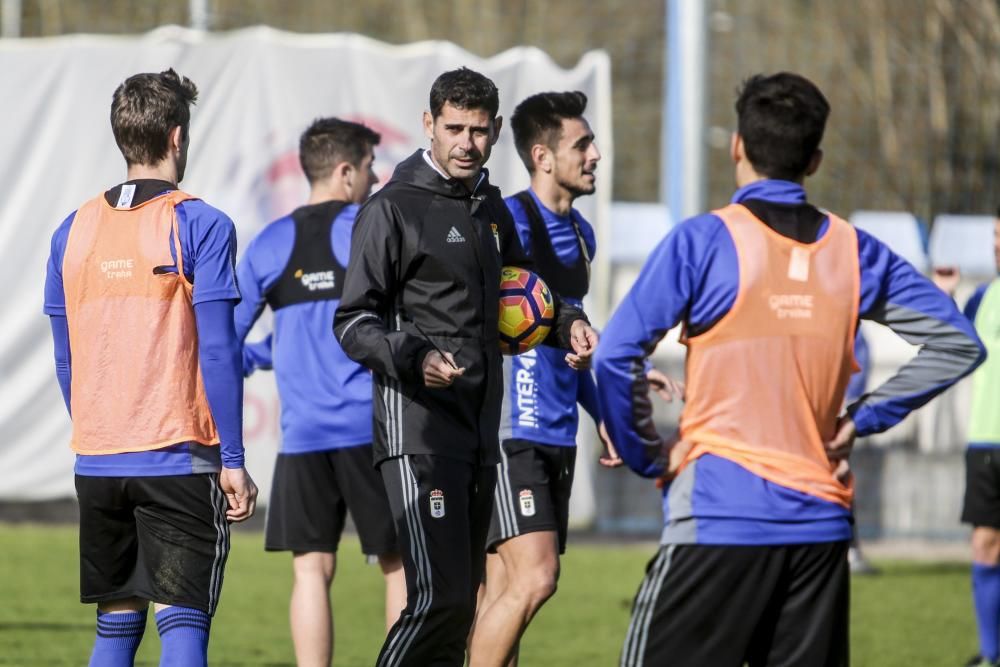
[236,118,406,667]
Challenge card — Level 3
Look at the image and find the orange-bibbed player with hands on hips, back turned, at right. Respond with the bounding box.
[596,73,983,667]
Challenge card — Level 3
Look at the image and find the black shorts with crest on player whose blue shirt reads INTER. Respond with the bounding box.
[486,439,576,554]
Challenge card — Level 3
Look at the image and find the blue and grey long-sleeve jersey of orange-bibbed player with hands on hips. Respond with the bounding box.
[595,180,984,544]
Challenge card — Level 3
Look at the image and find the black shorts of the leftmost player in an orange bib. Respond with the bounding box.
[76,474,229,614]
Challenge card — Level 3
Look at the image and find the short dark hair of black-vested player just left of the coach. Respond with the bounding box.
[299,118,382,183]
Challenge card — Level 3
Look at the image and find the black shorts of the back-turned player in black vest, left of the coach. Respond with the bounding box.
[264,445,397,556]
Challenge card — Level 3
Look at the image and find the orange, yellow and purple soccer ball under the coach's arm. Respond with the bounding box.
[499,266,556,354]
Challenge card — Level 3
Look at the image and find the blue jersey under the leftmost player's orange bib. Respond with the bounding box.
[44,187,244,477]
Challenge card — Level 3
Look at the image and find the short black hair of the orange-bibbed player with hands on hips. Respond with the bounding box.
[736,72,830,180]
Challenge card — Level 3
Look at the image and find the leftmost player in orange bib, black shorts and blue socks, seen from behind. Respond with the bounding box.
[45,70,257,667]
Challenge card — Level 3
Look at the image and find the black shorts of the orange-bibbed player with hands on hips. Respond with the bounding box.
[620,541,850,667]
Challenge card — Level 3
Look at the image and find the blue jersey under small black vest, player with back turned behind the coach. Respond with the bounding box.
[236,202,372,454]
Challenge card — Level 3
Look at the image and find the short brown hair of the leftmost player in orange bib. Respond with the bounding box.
[111,69,198,165]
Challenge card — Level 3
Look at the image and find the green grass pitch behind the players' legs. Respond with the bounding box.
[0,524,975,667]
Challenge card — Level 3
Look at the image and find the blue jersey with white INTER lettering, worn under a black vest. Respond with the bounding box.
[500,190,601,447]
